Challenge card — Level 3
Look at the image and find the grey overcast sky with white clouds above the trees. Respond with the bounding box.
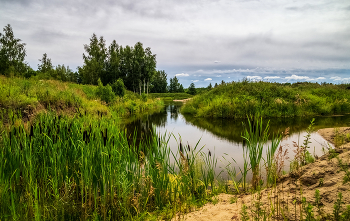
[0,0,350,87]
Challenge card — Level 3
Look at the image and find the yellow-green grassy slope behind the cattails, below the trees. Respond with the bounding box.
[0,76,162,121]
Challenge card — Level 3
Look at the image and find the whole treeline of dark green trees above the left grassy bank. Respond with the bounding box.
[0,25,176,93]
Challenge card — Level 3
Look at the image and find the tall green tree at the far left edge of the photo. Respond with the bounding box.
[0,24,28,76]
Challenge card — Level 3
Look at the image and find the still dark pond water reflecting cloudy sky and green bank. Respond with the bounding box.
[125,102,350,178]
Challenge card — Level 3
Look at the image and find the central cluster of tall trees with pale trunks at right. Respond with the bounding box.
[78,34,156,93]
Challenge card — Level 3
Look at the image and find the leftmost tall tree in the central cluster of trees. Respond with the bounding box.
[78,33,107,85]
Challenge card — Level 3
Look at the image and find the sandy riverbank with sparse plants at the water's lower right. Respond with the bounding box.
[173,127,350,221]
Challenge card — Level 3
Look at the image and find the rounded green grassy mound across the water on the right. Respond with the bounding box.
[182,81,350,118]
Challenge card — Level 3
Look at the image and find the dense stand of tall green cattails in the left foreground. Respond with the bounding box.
[0,113,219,220]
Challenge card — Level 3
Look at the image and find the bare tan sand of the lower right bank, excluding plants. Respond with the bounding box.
[173,127,350,221]
